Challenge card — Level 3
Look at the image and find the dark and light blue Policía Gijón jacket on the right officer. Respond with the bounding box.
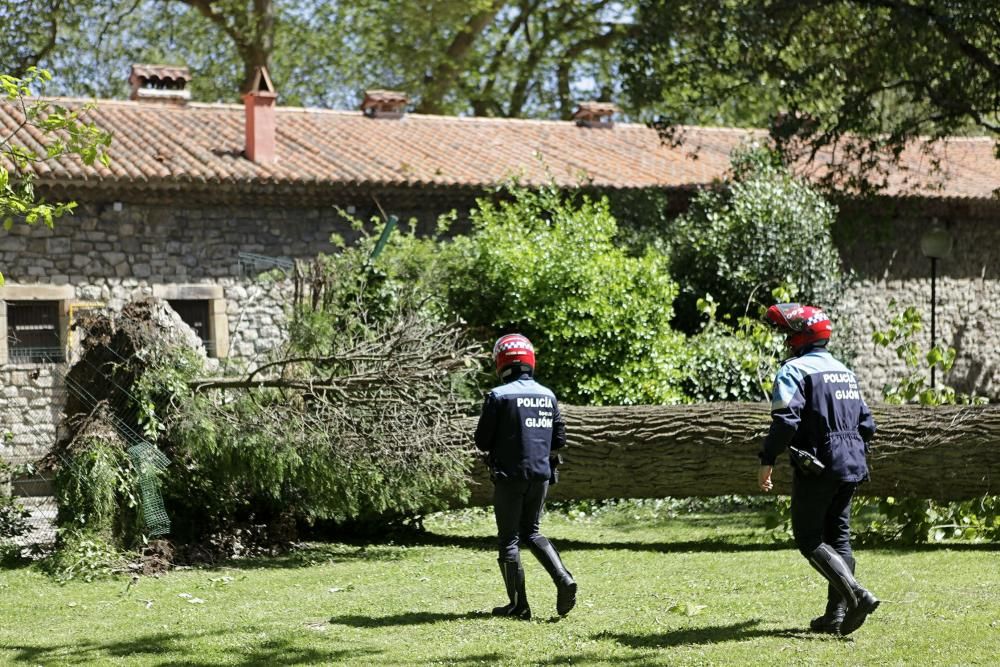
[760,347,875,482]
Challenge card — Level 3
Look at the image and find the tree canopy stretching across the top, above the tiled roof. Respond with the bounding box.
[0,0,1000,187]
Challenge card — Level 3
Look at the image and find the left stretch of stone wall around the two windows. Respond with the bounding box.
[0,204,357,462]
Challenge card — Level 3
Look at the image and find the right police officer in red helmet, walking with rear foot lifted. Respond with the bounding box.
[758,303,879,635]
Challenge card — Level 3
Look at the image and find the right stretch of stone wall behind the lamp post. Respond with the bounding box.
[835,201,1000,400]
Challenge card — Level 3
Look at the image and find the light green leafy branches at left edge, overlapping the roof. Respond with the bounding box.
[0,67,111,285]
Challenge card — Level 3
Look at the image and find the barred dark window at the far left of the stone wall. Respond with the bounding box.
[7,301,66,364]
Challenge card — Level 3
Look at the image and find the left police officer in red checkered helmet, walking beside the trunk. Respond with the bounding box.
[475,334,576,620]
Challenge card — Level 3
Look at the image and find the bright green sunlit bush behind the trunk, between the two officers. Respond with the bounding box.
[449,181,683,404]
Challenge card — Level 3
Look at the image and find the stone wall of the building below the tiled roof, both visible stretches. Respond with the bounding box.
[0,194,1000,474]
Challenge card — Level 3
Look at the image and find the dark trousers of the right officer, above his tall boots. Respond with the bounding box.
[792,471,858,560]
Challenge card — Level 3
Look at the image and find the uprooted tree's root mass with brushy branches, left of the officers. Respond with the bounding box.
[45,299,478,573]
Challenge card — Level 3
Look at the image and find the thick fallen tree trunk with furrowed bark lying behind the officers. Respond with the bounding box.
[468,403,1000,504]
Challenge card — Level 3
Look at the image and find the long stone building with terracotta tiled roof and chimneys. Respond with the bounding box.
[0,66,1000,470]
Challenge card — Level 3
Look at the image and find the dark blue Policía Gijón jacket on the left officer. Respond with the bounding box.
[475,373,566,480]
